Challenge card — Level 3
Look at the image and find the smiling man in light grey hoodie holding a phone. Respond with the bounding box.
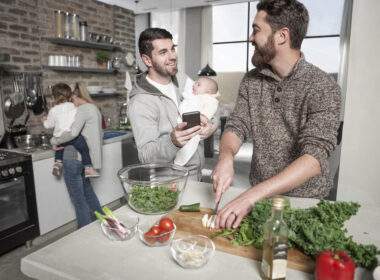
[128,28,216,180]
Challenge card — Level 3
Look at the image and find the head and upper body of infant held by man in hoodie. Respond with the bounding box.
[193,77,220,120]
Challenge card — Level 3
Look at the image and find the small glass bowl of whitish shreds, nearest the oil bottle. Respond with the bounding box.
[170,235,215,268]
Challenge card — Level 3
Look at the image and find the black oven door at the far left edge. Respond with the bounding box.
[0,172,39,254]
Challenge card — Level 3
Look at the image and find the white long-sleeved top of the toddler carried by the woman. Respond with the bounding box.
[44,102,77,137]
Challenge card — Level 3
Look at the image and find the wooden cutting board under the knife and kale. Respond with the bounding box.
[166,207,315,273]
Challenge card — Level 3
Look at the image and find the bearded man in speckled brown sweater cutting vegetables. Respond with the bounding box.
[211,0,341,228]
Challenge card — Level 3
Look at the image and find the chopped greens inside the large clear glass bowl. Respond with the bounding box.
[128,185,180,213]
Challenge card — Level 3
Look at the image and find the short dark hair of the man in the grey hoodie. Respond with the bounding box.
[139,28,173,58]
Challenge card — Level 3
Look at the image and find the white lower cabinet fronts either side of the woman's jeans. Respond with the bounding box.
[33,141,124,235]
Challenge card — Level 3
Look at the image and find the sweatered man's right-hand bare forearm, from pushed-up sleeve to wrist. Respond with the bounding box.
[248,154,321,202]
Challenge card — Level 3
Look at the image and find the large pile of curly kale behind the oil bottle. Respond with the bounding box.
[213,199,380,269]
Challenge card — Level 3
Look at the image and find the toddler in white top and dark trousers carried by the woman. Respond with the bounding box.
[41,83,99,178]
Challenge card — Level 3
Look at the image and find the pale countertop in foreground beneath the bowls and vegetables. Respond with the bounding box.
[21,181,380,280]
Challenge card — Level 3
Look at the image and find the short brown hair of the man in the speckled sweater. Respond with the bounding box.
[257,0,309,49]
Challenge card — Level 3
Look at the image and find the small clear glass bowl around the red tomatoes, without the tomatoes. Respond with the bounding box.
[137,221,177,247]
